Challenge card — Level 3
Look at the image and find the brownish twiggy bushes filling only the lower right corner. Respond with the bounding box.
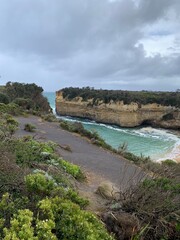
[104,164,180,240]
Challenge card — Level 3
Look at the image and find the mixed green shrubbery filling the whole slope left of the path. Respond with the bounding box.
[0,109,113,240]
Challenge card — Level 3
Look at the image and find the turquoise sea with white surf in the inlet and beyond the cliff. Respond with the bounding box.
[44,93,180,160]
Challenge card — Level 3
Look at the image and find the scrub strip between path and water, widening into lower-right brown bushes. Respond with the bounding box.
[60,121,180,240]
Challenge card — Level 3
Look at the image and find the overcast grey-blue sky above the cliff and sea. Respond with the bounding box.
[0,0,180,91]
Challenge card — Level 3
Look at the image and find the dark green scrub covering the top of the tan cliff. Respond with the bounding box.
[61,87,180,107]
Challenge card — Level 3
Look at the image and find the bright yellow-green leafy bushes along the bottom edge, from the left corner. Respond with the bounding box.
[0,196,113,240]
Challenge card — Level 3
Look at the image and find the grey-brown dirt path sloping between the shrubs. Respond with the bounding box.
[16,116,145,195]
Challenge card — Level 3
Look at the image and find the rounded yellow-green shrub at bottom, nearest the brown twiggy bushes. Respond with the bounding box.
[39,197,113,240]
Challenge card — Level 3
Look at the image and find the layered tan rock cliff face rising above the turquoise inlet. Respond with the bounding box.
[56,91,180,129]
